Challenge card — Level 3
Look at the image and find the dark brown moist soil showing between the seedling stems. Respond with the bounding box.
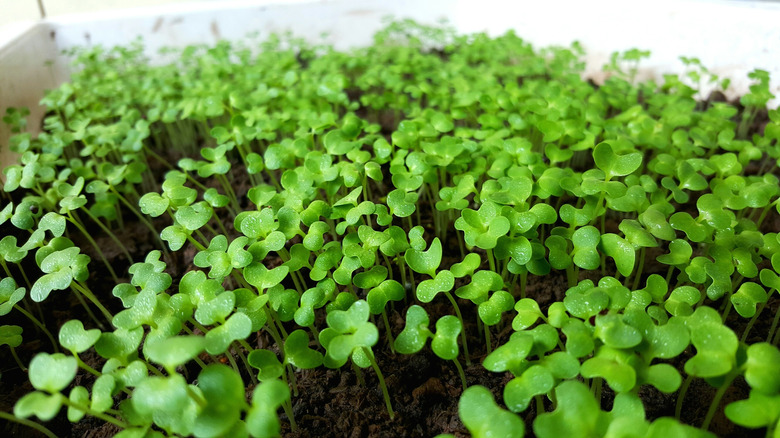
[0,97,780,438]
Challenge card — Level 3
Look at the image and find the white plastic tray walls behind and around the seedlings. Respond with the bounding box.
[0,0,780,169]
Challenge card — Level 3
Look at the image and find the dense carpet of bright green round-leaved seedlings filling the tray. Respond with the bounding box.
[0,21,780,438]
